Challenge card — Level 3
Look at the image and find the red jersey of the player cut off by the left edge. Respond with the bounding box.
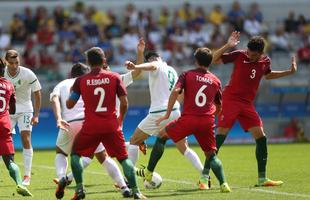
[0,77,16,117]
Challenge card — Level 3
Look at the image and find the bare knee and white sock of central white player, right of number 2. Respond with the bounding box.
[128,128,149,165]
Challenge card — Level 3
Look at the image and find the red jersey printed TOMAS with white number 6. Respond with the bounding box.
[176,68,222,115]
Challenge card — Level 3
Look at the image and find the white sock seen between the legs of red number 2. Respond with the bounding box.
[102,157,127,188]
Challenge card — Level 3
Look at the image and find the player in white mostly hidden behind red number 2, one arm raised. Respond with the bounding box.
[50,39,145,199]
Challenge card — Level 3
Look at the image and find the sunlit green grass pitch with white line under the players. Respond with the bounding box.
[0,144,310,200]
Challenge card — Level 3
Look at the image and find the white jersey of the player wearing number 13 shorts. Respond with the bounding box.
[4,66,41,113]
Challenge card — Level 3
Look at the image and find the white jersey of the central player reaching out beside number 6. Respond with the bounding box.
[149,60,180,112]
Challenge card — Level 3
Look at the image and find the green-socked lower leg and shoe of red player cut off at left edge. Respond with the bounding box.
[2,154,32,196]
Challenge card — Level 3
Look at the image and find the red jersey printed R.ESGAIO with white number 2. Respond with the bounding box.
[72,68,127,122]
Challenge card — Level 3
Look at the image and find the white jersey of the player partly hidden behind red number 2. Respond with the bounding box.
[50,78,84,121]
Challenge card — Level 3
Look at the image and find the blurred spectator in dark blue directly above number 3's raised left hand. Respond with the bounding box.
[228,1,245,31]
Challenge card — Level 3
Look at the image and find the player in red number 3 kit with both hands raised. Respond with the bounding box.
[209,32,297,186]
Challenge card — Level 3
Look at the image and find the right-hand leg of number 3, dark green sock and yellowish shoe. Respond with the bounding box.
[249,126,283,186]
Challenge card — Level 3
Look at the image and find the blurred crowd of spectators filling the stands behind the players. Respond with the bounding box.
[0,1,310,78]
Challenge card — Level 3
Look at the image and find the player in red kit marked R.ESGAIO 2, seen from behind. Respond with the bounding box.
[66,47,146,199]
